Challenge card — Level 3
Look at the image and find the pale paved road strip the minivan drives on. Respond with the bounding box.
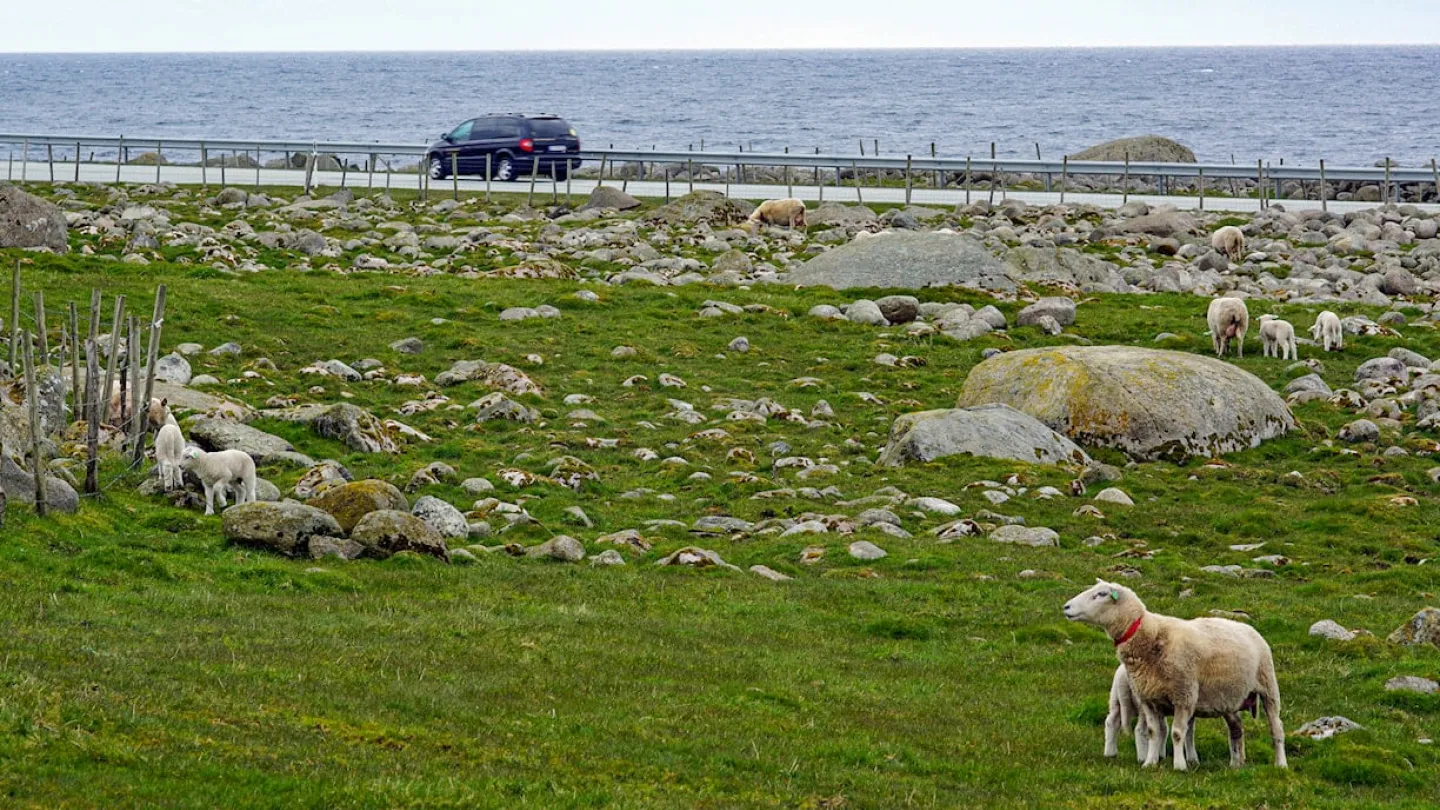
[6,161,1440,213]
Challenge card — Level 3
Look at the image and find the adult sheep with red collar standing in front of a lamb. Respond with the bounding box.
[1064,579,1286,771]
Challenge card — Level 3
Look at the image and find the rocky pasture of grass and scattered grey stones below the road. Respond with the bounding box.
[0,179,1440,807]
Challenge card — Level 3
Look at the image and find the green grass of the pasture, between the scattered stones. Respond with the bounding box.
[0,185,1440,809]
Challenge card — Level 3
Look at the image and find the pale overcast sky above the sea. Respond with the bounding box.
[0,0,1440,53]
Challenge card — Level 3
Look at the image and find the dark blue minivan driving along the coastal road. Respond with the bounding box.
[425,114,580,182]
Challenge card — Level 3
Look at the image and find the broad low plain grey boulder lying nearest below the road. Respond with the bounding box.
[785,231,1015,291]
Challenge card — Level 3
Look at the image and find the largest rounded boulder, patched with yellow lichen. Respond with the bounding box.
[959,346,1295,461]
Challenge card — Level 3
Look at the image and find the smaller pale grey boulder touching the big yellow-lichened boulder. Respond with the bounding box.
[880,405,1090,467]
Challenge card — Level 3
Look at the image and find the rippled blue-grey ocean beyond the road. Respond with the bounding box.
[0,46,1440,166]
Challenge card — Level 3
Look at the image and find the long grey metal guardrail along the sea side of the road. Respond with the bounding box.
[0,133,1440,184]
